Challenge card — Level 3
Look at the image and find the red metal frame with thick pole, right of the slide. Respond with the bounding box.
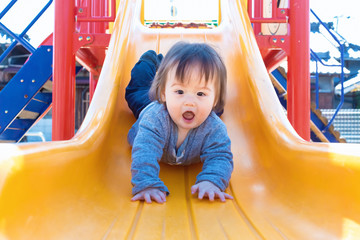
[248,0,310,141]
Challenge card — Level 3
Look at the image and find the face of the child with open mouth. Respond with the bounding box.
[161,68,216,132]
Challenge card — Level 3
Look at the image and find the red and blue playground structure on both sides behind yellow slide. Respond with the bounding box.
[0,0,344,142]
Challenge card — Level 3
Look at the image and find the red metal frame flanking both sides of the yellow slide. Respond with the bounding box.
[53,0,310,141]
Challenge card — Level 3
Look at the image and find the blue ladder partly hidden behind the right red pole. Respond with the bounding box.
[270,69,345,142]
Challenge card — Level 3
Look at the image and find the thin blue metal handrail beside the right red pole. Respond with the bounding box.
[310,9,345,132]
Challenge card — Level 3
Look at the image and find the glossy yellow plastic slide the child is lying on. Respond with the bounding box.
[0,0,360,240]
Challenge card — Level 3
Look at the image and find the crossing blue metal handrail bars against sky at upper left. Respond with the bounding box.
[0,0,53,62]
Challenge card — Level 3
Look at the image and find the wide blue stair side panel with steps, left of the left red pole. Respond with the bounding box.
[0,46,53,142]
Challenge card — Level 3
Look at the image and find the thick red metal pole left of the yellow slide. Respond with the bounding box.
[52,0,75,141]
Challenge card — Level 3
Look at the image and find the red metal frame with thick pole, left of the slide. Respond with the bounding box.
[52,0,116,141]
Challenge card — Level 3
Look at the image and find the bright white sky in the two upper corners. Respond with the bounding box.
[0,0,360,47]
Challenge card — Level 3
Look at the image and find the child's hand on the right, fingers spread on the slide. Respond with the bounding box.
[191,181,233,202]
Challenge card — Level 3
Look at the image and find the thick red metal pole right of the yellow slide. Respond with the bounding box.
[287,0,310,141]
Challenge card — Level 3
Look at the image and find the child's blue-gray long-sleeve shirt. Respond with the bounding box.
[128,102,233,195]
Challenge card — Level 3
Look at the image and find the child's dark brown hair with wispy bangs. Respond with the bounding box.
[149,42,227,112]
